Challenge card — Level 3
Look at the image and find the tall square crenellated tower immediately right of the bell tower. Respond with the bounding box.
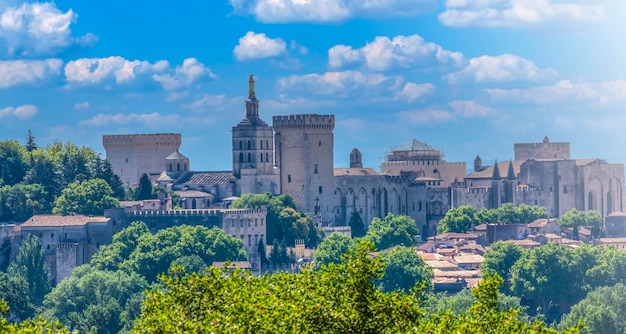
[273,114,335,223]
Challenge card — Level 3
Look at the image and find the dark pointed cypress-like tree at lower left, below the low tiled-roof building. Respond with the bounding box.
[8,234,50,305]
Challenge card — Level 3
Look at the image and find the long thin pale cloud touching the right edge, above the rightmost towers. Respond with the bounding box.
[487,79,626,105]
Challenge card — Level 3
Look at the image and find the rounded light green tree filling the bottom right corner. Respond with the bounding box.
[560,283,626,334]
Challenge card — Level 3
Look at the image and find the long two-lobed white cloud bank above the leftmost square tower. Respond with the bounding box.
[65,56,216,90]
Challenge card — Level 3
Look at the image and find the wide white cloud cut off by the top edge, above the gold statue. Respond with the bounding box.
[229,0,437,23]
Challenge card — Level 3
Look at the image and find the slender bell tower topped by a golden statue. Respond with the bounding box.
[232,75,280,194]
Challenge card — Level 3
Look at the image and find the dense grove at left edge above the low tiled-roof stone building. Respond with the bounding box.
[0,131,125,221]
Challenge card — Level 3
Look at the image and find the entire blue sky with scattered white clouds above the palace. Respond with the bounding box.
[0,0,626,170]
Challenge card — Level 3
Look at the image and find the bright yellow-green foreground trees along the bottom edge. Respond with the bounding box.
[133,241,576,333]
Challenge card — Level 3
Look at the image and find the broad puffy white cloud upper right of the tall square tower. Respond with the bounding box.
[328,35,465,71]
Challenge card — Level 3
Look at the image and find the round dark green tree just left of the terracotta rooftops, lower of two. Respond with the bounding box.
[378,246,433,293]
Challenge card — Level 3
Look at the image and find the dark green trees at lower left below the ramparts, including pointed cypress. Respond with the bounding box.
[0,222,247,333]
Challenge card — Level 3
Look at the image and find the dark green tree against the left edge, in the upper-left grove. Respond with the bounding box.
[0,140,27,186]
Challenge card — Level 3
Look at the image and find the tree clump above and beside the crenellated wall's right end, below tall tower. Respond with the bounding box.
[231,193,324,248]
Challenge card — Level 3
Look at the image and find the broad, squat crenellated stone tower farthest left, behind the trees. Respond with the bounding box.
[102,133,181,186]
